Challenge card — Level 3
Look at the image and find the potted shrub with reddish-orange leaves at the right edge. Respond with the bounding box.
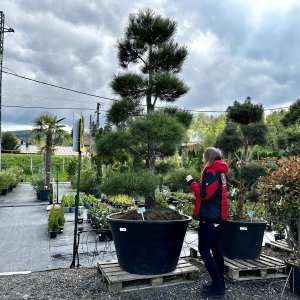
[258,157,300,294]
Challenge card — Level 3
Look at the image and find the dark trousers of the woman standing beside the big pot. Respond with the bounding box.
[198,221,224,281]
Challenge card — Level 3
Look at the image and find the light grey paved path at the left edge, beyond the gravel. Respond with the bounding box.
[0,183,51,273]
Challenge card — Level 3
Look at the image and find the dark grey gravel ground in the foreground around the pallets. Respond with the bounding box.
[0,266,300,300]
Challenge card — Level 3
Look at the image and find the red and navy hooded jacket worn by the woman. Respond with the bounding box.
[188,160,229,222]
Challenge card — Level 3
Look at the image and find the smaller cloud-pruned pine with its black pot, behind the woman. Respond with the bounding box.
[216,97,267,259]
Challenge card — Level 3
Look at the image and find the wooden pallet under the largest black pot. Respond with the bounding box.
[97,259,199,292]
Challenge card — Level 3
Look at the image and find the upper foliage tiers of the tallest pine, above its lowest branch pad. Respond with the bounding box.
[97,9,192,207]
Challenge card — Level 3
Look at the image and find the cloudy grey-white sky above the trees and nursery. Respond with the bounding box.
[0,0,300,131]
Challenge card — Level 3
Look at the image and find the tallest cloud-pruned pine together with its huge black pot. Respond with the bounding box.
[97,9,192,274]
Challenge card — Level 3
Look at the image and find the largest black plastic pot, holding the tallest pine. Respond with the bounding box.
[108,214,191,275]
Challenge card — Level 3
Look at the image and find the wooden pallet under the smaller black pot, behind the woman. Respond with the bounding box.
[190,248,286,282]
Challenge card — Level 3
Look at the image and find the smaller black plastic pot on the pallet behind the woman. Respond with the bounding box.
[221,221,267,259]
